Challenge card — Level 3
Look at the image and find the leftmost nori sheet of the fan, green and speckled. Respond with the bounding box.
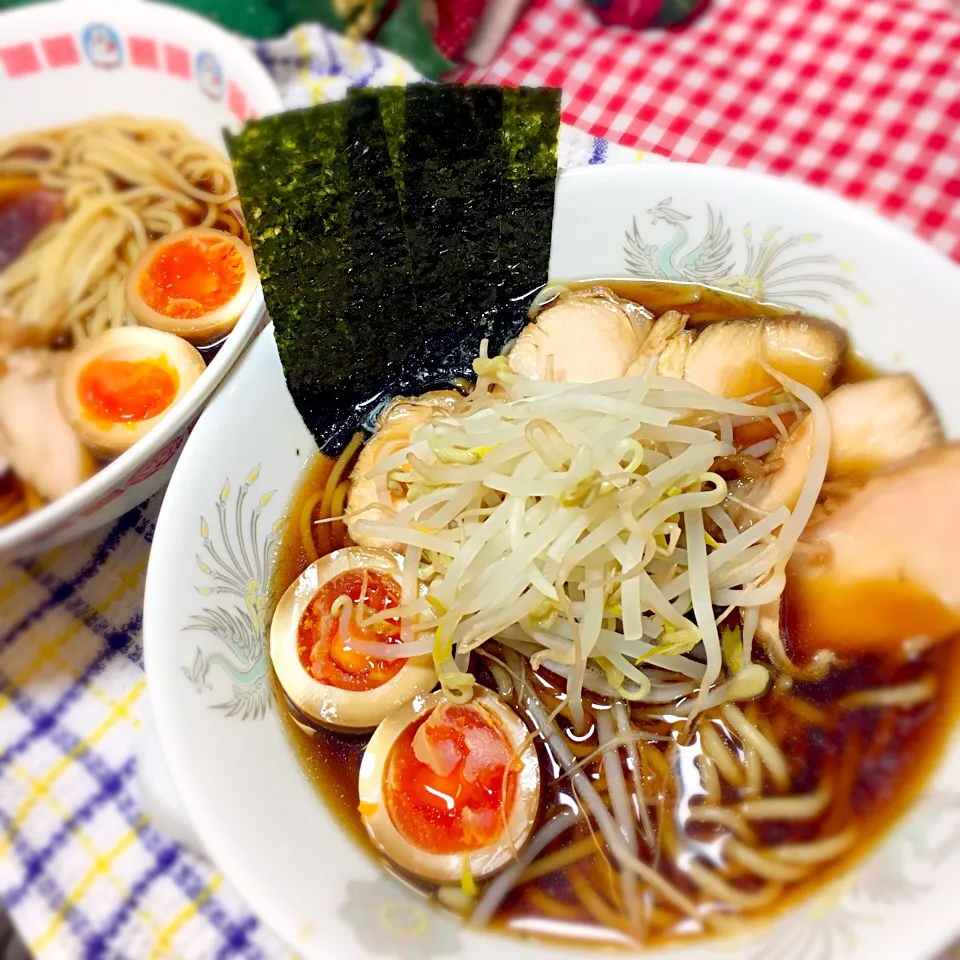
[228,99,416,452]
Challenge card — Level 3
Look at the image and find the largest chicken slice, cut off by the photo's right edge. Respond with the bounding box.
[785,444,960,657]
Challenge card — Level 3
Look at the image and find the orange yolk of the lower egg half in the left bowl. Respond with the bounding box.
[77,356,180,423]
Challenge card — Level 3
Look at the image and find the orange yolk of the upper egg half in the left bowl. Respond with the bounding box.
[138,237,246,320]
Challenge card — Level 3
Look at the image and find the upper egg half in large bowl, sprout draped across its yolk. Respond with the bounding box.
[270,547,437,733]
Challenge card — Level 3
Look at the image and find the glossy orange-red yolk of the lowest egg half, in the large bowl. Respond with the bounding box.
[383,704,516,854]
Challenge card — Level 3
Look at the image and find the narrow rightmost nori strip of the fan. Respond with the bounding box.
[498,87,560,353]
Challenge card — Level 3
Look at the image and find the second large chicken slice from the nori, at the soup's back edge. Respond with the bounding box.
[683,316,847,397]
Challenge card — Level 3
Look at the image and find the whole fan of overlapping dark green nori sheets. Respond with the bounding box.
[227,84,559,453]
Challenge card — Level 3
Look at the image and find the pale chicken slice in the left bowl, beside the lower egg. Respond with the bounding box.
[0,350,98,500]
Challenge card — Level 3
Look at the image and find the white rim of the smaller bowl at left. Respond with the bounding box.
[0,0,284,555]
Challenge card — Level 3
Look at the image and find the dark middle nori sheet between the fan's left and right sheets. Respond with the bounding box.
[400,84,504,391]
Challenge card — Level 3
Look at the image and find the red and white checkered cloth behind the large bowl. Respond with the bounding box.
[461,0,960,260]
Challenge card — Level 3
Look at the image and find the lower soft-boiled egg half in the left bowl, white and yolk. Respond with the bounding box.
[57,327,206,459]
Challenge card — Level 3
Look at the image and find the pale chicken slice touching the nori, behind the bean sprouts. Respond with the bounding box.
[509,287,653,383]
